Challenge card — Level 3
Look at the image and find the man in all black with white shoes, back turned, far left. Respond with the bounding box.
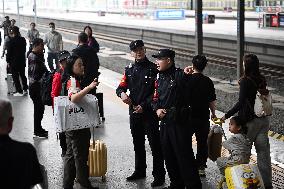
[6,26,28,96]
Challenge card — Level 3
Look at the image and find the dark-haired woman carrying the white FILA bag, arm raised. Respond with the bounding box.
[63,55,99,189]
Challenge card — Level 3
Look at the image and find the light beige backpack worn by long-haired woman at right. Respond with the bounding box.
[254,91,273,117]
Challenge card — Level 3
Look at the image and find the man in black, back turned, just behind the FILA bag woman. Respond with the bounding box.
[72,32,100,94]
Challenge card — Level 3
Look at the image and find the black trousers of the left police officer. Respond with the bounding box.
[130,114,166,179]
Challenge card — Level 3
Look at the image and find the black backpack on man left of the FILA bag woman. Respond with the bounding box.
[40,71,54,106]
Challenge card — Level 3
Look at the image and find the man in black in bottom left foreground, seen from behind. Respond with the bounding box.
[0,98,43,189]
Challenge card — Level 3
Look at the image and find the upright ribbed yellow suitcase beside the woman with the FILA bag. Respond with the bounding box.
[88,140,107,182]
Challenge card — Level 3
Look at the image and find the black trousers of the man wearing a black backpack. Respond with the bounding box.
[29,83,44,132]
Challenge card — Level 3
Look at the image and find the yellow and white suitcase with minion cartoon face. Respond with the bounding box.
[225,164,265,189]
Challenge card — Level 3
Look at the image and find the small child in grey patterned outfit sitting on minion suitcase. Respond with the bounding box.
[216,116,251,183]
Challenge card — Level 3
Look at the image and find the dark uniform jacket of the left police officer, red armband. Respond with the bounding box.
[116,57,158,114]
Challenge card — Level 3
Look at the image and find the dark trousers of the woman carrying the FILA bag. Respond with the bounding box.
[63,128,91,188]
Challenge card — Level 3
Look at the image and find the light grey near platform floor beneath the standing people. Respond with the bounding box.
[0,52,284,189]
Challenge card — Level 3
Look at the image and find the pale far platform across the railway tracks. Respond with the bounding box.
[3,10,284,42]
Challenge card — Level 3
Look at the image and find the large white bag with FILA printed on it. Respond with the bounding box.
[54,94,101,132]
